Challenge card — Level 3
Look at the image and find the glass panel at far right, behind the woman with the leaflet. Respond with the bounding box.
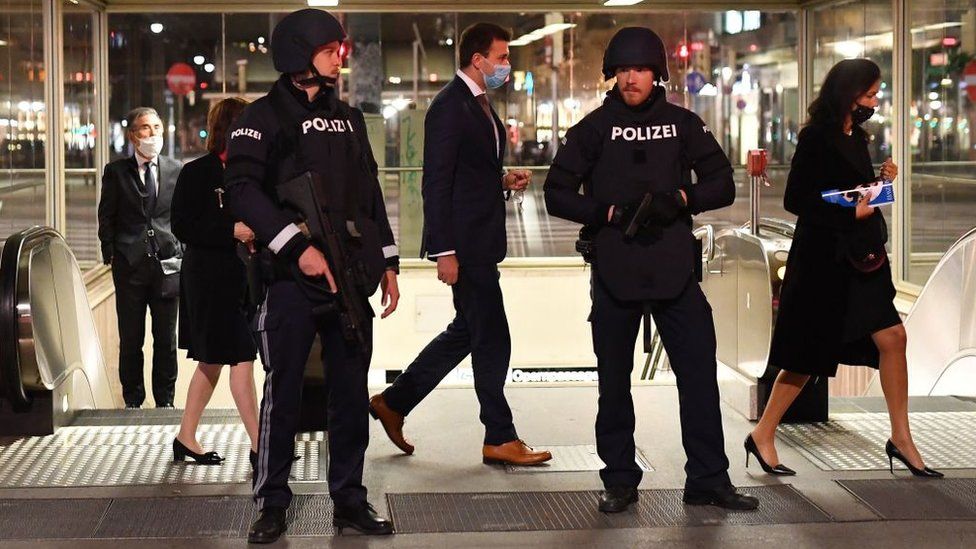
[906,0,976,284]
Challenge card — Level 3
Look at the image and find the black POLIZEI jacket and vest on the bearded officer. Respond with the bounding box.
[545,87,735,301]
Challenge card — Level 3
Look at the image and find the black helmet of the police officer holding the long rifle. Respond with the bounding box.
[271,8,346,74]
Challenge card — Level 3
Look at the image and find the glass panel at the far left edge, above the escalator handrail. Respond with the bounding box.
[0,0,47,241]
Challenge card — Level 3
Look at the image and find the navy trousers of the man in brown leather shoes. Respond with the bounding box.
[383,264,518,445]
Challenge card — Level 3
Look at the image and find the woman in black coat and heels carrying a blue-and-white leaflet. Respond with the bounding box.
[745,59,942,477]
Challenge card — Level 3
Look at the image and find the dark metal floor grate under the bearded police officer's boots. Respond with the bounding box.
[387,485,832,534]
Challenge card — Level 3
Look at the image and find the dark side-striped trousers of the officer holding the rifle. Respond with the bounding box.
[254,280,369,509]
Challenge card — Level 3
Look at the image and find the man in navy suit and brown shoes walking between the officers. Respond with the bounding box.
[370,23,552,465]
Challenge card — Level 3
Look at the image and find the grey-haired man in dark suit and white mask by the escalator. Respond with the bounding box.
[98,107,182,408]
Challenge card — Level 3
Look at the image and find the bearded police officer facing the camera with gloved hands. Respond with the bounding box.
[545,27,758,513]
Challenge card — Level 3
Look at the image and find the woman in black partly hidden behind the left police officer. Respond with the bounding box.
[172,98,258,465]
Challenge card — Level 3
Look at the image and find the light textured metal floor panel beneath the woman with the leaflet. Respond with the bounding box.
[779,412,976,471]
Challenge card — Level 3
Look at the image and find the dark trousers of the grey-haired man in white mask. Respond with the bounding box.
[112,253,179,406]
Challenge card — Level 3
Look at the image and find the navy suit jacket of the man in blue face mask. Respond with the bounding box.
[420,76,506,265]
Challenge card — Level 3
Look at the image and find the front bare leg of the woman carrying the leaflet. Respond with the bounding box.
[871,324,925,469]
